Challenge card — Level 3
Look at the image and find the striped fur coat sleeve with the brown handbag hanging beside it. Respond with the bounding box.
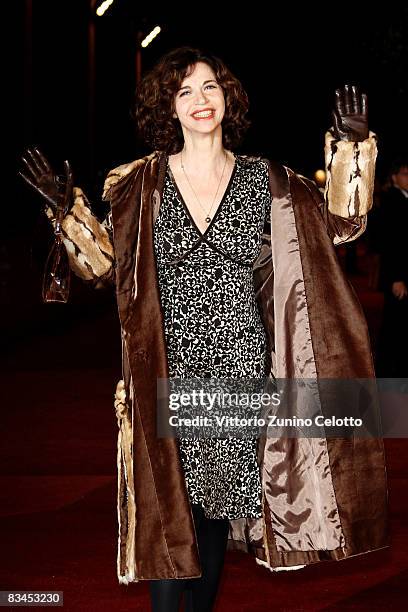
[45,187,115,288]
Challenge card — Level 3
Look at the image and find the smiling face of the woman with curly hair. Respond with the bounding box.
[173,62,225,134]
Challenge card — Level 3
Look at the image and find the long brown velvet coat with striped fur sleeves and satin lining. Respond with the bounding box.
[47,134,389,584]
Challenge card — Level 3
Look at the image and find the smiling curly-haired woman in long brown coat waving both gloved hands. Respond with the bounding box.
[20,47,388,610]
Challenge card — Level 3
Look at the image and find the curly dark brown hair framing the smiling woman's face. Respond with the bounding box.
[133,47,251,154]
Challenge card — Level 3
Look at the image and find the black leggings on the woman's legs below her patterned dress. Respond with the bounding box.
[149,504,233,612]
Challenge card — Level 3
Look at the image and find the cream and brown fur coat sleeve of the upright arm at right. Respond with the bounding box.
[302,132,377,245]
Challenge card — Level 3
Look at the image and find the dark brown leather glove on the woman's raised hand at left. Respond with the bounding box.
[19,147,73,212]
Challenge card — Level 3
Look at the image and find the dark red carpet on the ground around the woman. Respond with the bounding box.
[0,241,408,612]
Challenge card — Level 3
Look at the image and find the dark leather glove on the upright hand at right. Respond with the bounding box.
[331,85,369,142]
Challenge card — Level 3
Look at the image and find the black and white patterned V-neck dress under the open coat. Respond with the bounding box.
[154,155,270,519]
